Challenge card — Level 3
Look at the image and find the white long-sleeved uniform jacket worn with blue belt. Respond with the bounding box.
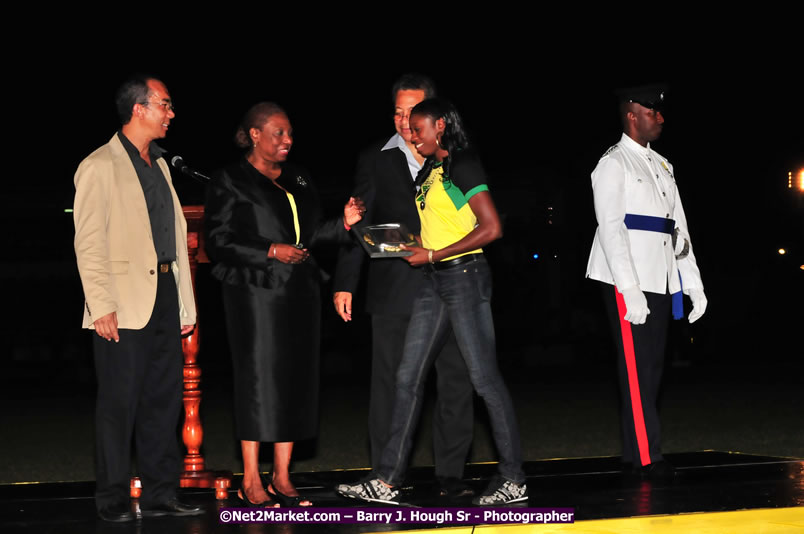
[586,134,703,294]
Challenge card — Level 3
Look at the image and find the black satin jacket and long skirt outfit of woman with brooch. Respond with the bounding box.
[205,158,349,442]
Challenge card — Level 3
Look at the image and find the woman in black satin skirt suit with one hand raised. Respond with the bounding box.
[205,102,363,507]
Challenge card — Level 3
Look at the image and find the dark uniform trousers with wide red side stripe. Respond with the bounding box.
[601,284,671,466]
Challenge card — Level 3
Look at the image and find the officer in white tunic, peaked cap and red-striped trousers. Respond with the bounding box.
[586,86,707,479]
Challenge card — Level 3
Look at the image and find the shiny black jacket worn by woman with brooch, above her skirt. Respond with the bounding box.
[204,158,350,296]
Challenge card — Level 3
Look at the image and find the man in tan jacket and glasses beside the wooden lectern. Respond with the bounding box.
[73,77,201,522]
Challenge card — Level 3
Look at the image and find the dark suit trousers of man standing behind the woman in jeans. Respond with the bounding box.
[369,314,474,478]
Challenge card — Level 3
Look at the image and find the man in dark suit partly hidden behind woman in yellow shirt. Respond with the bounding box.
[333,74,473,498]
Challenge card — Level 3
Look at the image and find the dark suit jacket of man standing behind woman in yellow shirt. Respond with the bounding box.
[333,140,423,315]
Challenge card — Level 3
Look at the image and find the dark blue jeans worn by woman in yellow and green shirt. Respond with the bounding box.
[375,255,525,485]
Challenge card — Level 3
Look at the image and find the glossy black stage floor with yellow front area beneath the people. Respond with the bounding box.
[0,451,804,534]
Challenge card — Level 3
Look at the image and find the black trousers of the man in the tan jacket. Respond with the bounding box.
[93,272,183,509]
